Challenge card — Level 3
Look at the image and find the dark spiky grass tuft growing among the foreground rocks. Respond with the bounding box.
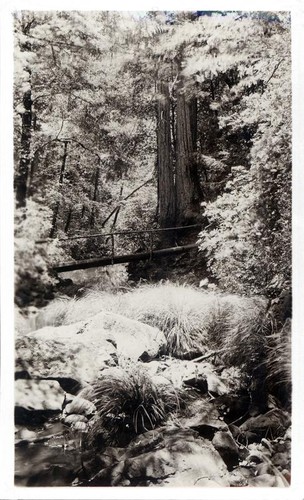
[89,363,183,446]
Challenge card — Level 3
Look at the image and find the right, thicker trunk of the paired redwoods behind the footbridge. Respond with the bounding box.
[175,76,201,225]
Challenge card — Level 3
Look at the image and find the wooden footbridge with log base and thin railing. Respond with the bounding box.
[36,224,201,273]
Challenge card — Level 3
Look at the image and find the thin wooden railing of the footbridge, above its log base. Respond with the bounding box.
[36,224,201,263]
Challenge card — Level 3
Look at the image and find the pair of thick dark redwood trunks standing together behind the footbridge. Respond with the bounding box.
[157,63,201,227]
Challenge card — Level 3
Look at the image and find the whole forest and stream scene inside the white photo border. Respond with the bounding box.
[14,11,292,487]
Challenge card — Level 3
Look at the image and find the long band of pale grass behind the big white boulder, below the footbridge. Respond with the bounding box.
[39,283,265,366]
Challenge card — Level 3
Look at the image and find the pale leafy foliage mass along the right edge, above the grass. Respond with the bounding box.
[197,12,291,296]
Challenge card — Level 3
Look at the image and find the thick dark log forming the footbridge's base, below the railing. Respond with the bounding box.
[53,243,198,273]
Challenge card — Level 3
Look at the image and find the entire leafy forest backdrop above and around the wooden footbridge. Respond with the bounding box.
[15,11,291,304]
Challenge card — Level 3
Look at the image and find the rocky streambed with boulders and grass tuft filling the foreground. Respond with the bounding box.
[15,306,290,487]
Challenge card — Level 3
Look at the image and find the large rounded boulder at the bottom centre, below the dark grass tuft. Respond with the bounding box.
[85,427,229,487]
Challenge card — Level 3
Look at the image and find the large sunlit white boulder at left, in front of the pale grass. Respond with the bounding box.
[16,312,165,393]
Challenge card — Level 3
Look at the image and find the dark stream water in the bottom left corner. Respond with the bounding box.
[15,423,82,486]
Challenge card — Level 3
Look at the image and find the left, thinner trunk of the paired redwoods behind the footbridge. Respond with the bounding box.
[157,82,175,227]
